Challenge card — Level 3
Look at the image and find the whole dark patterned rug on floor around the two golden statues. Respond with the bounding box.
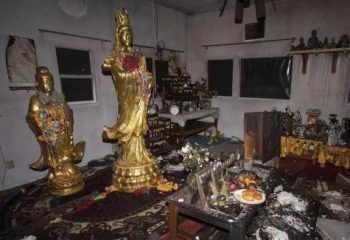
[0,163,180,240]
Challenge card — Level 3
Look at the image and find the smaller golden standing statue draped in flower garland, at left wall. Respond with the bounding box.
[27,67,85,196]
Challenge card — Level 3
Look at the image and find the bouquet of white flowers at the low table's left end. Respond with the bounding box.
[180,143,210,189]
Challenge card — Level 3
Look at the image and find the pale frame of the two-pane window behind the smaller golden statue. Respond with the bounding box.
[54,44,97,105]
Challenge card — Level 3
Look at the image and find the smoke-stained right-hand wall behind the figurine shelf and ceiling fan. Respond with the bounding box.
[189,0,350,137]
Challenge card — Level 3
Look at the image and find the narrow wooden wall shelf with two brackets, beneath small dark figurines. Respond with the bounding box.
[288,47,350,74]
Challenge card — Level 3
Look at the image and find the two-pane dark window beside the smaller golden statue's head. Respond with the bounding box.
[56,48,95,102]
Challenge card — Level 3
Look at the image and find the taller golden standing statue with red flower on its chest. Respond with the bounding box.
[102,9,162,192]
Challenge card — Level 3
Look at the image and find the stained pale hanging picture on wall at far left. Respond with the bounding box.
[6,36,37,90]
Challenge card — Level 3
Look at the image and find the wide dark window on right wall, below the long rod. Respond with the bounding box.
[240,57,293,99]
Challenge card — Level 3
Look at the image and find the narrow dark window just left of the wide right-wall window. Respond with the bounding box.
[208,59,233,96]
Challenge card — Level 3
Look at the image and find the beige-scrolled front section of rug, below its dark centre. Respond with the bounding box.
[31,201,168,240]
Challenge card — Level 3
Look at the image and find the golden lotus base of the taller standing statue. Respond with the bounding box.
[112,161,162,192]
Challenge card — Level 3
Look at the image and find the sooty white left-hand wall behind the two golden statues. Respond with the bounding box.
[0,0,188,189]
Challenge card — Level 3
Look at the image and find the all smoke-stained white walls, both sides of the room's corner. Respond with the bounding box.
[0,0,350,189]
